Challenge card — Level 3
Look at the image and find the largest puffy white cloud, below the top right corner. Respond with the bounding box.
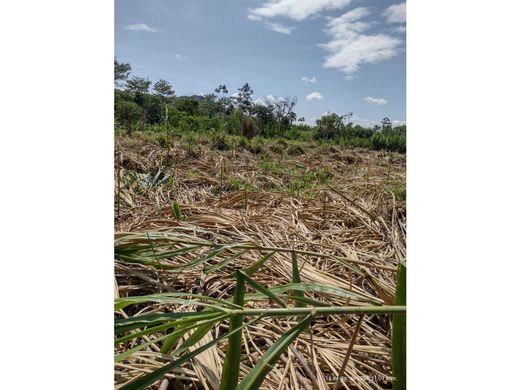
[320,7,402,79]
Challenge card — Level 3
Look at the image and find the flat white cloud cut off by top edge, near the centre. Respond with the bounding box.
[248,0,352,21]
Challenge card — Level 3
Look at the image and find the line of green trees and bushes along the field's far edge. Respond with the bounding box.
[114,59,406,152]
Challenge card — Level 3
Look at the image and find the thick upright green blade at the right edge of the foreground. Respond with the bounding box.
[392,263,406,390]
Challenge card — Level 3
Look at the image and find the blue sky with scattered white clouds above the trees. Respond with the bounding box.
[115,0,406,125]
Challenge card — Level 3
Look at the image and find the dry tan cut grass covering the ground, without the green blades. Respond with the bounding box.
[115,138,406,389]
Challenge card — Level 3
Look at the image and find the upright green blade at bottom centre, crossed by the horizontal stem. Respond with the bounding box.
[220,271,246,390]
